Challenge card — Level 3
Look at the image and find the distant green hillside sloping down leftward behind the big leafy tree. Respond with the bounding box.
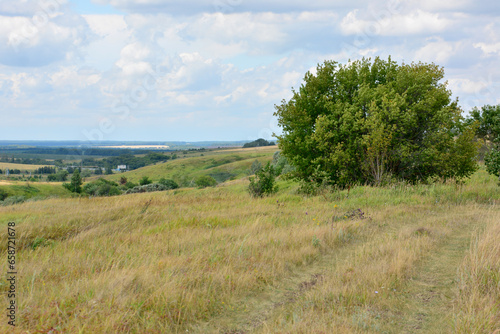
[105,146,277,187]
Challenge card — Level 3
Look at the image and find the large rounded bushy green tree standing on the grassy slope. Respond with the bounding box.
[275,57,477,186]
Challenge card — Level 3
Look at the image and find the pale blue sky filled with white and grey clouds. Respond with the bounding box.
[0,0,500,142]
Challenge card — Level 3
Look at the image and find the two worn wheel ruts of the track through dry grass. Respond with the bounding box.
[190,207,482,334]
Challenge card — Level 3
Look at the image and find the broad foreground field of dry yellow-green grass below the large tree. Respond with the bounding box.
[0,164,500,333]
